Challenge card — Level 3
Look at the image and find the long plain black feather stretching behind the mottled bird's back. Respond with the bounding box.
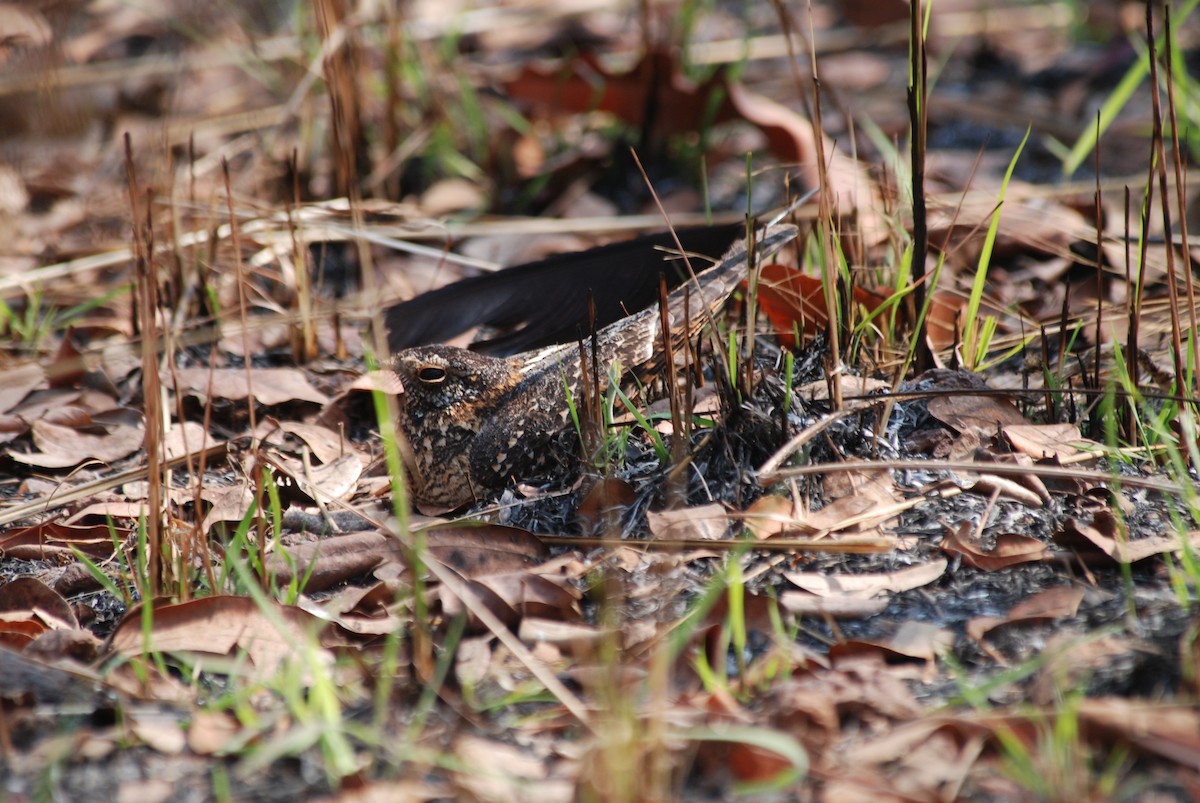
[384,223,745,356]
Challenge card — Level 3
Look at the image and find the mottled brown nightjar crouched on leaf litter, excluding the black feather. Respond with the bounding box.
[385,220,796,510]
